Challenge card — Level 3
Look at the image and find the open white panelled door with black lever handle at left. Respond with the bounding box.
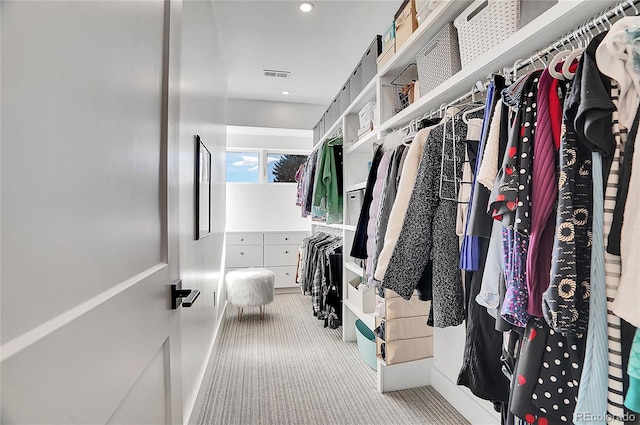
[0,0,188,424]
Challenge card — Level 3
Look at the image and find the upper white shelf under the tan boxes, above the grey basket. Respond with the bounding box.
[378,0,473,78]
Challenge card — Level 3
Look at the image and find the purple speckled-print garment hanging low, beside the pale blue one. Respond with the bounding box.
[500,228,529,328]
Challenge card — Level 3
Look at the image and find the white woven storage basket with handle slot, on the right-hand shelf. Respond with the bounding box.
[453,0,520,67]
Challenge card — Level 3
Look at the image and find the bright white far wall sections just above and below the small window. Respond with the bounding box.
[227,126,312,231]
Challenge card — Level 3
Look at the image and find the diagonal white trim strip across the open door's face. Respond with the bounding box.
[0,263,168,362]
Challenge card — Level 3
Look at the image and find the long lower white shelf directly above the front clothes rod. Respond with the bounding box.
[379,0,602,133]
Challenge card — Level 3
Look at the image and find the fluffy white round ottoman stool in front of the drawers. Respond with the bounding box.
[225,268,275,321]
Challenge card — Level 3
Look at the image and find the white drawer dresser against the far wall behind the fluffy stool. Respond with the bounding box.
[226,232,308,288]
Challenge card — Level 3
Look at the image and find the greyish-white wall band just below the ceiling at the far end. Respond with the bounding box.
[228,99,329,130]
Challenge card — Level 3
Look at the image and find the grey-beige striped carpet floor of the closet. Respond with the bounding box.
[198,293,468,425]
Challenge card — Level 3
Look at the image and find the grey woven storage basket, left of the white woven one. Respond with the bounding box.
[416,22,460,96]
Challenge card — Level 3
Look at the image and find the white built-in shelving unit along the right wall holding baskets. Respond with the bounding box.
[314,0,616,416]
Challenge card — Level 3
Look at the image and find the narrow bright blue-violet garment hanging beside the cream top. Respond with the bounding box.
[460,81,495,271]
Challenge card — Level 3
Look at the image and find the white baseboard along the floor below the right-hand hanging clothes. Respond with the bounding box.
[431,367,500,425]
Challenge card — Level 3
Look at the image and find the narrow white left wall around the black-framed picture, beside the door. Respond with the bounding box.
[180,1,227,423]
